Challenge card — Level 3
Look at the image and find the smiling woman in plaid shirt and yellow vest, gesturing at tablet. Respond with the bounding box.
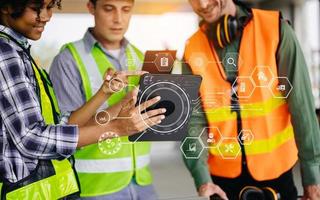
[0,0,164,199]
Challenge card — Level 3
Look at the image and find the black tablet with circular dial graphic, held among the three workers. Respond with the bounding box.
[129,74,202,142]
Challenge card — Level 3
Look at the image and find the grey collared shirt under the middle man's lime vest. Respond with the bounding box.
[49,28,134,113]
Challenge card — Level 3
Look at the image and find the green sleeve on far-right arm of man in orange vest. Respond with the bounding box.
[277,22,320,186]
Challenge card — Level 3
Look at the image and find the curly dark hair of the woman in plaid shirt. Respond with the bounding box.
[0,0,61,22]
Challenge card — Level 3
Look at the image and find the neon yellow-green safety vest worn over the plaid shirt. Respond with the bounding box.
[0,30,79,200]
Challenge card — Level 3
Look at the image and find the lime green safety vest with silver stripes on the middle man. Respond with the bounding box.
[65,40,152,197]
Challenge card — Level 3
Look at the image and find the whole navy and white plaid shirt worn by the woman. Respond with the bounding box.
[0,25,78,182]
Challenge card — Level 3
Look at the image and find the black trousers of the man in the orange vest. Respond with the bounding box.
[211,166,298,200]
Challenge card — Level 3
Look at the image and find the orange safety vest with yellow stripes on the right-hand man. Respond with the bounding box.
[184,9,297,181]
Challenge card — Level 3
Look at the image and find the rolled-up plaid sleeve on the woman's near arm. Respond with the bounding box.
[0,45,79,159]
